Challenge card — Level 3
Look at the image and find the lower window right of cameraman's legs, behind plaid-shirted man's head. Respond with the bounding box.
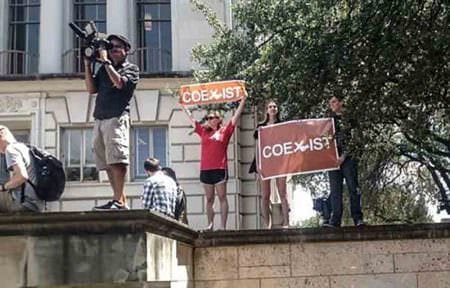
[132,127,168,179]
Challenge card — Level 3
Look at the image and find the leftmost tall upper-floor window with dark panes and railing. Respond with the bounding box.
[7,0,40,74]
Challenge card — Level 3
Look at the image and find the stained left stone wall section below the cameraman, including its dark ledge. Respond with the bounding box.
[0,210,197,288]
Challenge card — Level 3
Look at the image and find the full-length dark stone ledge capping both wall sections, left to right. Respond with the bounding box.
[0,210,450,247]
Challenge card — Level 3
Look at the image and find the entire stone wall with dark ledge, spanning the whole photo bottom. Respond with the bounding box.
[0,210,450,288]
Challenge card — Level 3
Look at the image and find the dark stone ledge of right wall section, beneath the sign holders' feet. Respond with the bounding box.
[195,223,450,247]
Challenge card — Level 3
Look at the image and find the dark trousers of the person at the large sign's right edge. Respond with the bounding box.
[328,157,363,226]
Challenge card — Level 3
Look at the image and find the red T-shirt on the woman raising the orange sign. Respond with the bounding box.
[195,121,234,170]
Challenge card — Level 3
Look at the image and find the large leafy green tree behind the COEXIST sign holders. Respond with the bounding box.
[191,0,450,221]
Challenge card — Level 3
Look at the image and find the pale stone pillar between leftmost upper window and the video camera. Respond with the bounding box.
[39,0,64,73]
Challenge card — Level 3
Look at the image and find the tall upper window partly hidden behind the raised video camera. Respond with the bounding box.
[65,0,106,72]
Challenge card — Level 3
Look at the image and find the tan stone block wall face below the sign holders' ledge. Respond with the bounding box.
[194,226,450,288]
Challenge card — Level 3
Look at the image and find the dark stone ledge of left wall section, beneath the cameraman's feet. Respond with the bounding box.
[0,210,198,244]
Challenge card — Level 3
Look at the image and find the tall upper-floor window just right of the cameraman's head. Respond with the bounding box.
[136,0,172,73]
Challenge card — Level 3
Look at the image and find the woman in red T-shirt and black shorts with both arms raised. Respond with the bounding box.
[182,97,245,230]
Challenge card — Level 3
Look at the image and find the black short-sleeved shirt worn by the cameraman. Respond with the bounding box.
[94,61,139,120]
